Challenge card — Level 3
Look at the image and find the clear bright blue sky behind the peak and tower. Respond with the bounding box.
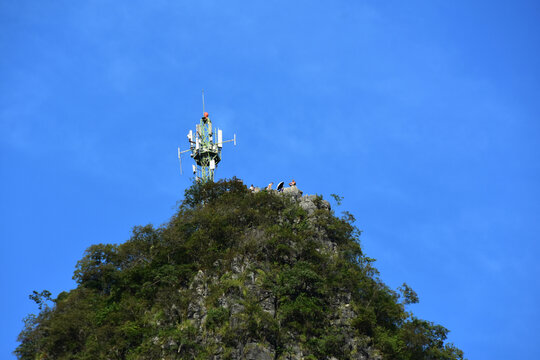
[0,0,540,359]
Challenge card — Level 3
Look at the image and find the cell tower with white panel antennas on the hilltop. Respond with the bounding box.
[178,91,236,182]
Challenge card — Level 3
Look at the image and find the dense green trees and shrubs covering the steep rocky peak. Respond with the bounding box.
[15,179,463,360]
